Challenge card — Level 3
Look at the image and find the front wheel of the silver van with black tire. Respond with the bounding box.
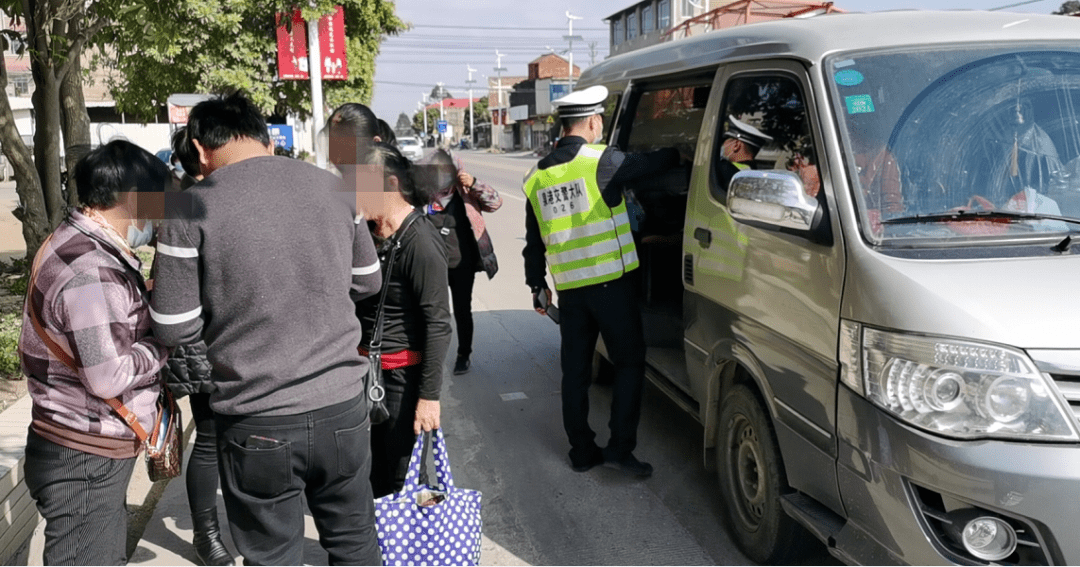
[716,384,812,565]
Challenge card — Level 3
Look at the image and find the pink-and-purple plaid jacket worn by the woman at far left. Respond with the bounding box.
[18,212,168,447]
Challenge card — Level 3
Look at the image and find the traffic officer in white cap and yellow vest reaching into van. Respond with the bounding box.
[522,86,680,477]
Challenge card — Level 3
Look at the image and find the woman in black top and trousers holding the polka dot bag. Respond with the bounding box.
[356,143,450,498]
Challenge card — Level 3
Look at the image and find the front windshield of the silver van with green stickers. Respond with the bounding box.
[824,44,1080,246]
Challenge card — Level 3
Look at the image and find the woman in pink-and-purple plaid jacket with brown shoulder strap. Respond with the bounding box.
[18,140,170,565]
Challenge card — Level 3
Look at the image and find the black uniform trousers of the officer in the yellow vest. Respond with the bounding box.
[558,274,645,464]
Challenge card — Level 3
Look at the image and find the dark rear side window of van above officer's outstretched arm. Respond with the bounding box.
[626,84,712,152]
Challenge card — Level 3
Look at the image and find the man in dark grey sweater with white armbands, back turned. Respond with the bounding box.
[151,95,381,565]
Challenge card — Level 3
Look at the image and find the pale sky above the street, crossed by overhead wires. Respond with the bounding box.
[372,0,1062,124]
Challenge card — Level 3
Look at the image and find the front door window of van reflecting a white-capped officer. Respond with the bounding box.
[710,75,821,203]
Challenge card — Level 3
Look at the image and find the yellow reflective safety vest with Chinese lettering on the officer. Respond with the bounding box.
[524,145,638,291]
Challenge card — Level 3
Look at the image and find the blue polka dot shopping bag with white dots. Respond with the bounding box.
[375,429,483,565]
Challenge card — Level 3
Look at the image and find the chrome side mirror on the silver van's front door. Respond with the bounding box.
[728,170,823,231]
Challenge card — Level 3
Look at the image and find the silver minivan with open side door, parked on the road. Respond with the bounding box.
[579,12,1080,565]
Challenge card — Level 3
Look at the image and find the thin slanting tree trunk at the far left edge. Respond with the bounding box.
[0,48,51,261]
